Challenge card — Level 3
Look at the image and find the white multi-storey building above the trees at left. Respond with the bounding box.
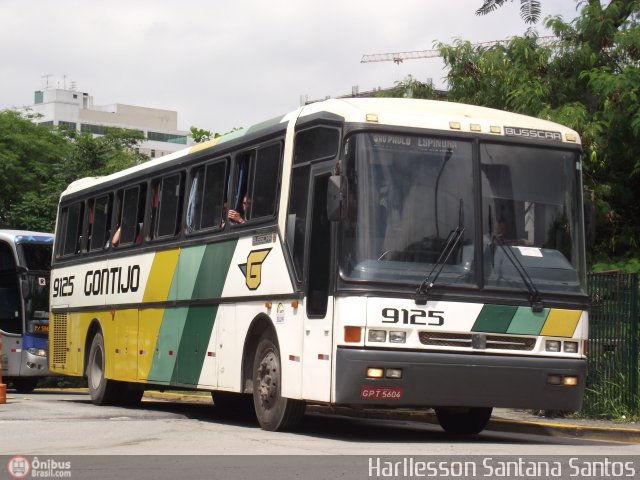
[26,88,193,158]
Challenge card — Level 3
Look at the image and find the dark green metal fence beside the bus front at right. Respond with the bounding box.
[583,272,639,416]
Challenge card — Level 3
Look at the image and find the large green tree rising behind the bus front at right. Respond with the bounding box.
[390,0,640,261]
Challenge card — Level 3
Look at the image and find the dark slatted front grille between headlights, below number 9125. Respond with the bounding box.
[419,332,536,351]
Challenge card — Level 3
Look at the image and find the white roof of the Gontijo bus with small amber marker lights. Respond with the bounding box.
[62,98,580,197]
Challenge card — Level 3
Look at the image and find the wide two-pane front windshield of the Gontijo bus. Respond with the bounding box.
[340,133,584,292]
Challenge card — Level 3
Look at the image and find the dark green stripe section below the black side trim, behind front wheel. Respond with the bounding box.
[171,306,218,385]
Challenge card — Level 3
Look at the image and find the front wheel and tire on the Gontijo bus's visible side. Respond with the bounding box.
[253,330,305,432]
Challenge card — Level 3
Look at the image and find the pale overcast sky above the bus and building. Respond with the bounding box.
[0,0,577,133]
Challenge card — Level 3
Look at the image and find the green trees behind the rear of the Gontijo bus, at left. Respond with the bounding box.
[0,110,148,231]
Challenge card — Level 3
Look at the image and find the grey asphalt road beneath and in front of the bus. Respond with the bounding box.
[0,391,640,480]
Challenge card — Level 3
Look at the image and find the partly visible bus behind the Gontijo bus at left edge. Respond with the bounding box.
[0,230,53,392]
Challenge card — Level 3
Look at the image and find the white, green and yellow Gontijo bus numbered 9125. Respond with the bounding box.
[50,98,588,433]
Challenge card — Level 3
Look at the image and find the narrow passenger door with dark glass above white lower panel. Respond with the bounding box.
[302,168,333,401]
